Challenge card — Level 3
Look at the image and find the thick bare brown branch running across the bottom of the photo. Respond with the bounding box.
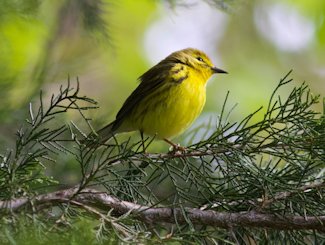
[0,188,325,231]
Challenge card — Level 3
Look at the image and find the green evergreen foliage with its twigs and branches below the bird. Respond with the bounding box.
[0,73,325,244]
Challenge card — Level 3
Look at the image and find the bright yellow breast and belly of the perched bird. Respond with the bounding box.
[128,79,206,139]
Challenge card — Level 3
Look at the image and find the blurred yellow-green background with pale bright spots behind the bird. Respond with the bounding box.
[0,0,325,165]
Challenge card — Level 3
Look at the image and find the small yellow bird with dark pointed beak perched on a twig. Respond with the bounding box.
[93,48,227,147]
